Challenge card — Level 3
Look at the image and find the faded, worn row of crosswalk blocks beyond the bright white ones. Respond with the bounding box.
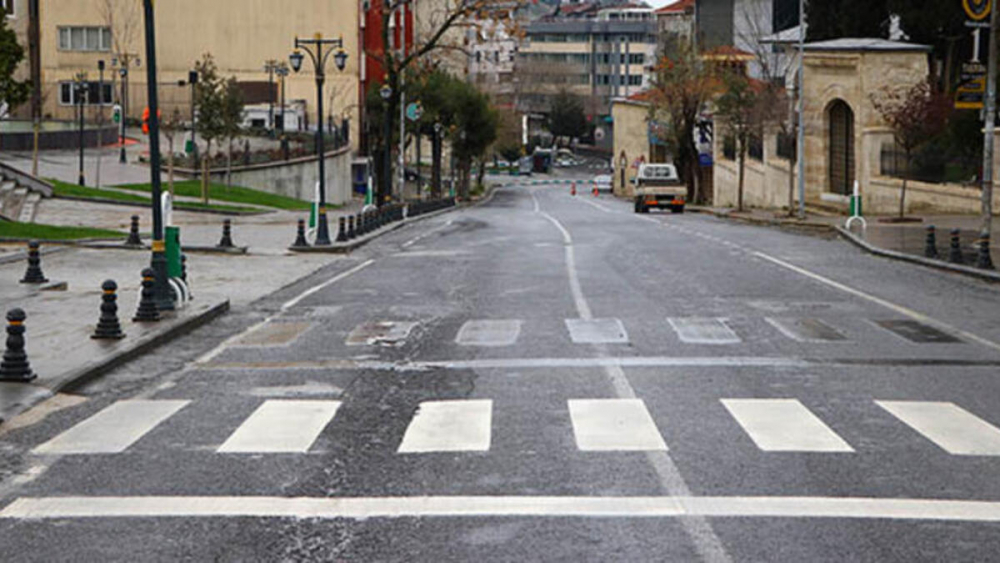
[345,317,963,347]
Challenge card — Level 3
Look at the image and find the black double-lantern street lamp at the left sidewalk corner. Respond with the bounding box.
[290,34,347,246]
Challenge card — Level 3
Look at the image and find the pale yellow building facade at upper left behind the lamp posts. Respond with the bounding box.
[32,0,362,146]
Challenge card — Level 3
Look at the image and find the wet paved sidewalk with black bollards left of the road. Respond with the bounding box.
[0,212,343,420]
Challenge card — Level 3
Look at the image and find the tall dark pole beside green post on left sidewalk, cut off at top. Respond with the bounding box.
[142,0,174,311]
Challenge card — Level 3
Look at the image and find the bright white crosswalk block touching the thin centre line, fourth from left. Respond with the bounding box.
[568,399,667,452]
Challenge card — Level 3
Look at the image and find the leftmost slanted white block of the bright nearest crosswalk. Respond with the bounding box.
[34,401,190,454]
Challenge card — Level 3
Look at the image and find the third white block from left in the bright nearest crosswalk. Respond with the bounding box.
[398,399,493,453]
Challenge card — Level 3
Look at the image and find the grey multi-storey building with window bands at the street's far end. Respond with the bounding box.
[515,4,657,117]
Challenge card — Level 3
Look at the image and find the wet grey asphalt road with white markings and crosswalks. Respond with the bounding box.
[0,186,1000,561]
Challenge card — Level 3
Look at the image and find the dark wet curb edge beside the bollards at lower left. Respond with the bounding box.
[0,299,229,423]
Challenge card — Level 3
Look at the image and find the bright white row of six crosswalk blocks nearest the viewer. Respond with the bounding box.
[34,397,1000,457]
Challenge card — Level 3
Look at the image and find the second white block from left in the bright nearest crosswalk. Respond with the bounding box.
[218,400,340,453]
